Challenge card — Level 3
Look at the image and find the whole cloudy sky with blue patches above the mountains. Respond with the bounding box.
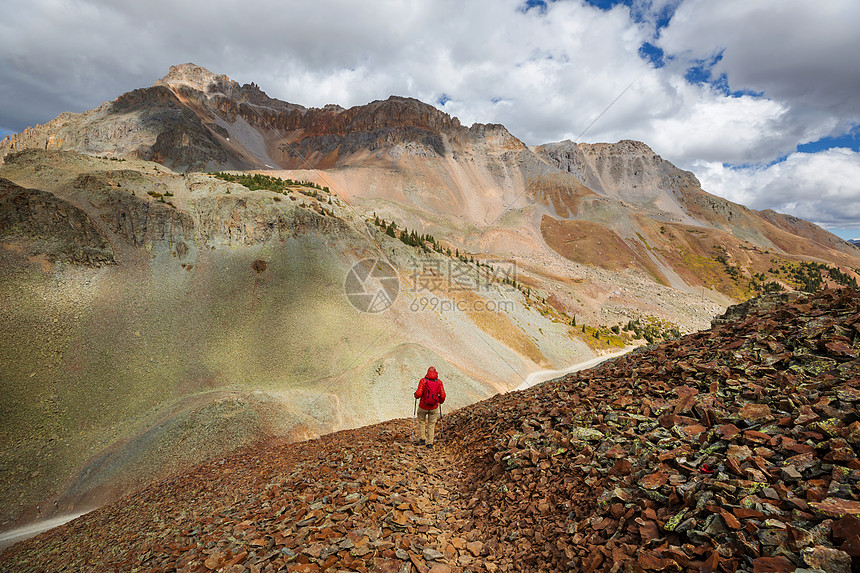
[5,0,860,238]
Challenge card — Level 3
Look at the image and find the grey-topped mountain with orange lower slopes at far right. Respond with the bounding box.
[536,141,859,299]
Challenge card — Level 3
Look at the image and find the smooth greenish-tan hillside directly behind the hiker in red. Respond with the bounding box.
[0,150,629,527]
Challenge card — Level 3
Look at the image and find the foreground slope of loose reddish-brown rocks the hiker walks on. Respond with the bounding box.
[0,291,860,573]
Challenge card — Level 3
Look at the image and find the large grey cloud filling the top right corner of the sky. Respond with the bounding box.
[659,0,860,116]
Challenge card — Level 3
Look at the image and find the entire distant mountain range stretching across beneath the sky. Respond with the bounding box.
[0,64,860,292]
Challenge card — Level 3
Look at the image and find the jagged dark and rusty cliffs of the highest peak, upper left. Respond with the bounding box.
[0,64,498,169]
